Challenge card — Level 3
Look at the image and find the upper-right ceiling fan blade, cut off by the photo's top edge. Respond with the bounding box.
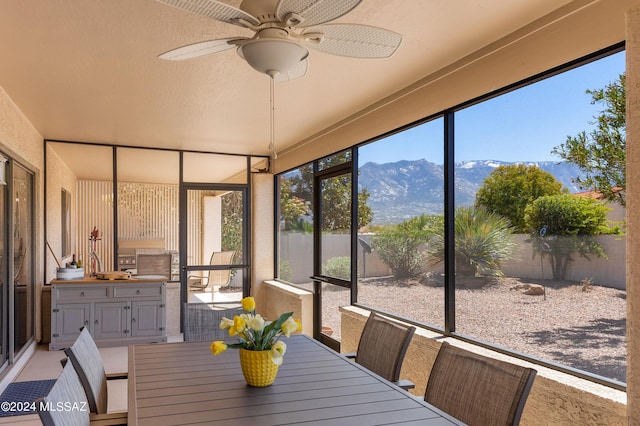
[276,0,362,27]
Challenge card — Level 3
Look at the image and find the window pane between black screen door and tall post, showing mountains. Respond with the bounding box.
[357,118,444,327]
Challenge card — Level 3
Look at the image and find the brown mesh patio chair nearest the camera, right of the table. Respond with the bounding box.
[424,342,536,426]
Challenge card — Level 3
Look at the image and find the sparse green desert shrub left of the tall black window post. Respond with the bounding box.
[372,215,444,278]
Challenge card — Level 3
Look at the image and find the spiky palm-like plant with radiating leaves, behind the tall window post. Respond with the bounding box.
[428,207,516,276]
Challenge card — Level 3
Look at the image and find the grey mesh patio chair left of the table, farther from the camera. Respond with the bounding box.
[64,327,127,424]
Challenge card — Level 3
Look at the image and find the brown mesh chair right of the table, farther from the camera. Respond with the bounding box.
[345,312,416,390]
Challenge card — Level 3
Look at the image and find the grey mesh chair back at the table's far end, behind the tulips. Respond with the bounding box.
[184,302,244,342]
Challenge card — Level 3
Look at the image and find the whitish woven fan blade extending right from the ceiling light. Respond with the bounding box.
[302,24,402,58]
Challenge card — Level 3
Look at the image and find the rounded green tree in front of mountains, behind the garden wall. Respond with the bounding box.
[476,164,562,232]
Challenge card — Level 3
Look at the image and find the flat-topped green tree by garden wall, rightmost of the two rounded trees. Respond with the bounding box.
[525,194,611,280]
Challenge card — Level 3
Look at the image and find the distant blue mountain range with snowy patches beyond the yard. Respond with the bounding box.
[358,160,580,225]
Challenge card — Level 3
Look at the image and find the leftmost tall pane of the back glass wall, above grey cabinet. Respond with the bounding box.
[45,142,114,282]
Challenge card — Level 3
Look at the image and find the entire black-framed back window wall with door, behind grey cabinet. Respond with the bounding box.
[46,141,258,337]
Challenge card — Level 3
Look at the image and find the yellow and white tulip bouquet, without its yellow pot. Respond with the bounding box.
[211,297,302,365]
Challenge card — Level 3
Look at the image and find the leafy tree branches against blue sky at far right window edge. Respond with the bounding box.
[551,74,626,206]
